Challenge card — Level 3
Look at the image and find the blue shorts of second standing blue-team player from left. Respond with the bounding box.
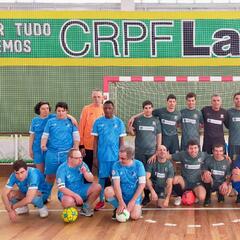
[44,150,68,175]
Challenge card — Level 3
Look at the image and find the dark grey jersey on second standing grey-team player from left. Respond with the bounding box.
[153,107,181,136]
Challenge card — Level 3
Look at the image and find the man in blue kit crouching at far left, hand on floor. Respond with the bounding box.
[2,160,49,222]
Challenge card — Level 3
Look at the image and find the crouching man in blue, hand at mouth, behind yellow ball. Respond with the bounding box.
[56,149,101,217]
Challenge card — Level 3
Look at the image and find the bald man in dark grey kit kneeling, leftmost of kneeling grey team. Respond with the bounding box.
[146,145,174,207]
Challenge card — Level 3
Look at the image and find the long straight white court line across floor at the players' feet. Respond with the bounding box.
[0,207,240,213]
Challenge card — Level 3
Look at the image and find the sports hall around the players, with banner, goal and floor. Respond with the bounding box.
[0,0,240,240]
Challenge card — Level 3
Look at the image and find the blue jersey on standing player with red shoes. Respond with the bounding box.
[92,116,126,162]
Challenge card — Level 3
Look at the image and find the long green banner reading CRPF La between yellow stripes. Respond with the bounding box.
[0,19,240,59]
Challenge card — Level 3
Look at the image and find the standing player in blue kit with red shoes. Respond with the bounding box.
[92,100,126,210]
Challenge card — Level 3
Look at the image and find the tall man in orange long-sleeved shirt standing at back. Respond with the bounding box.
[78,89,104,171]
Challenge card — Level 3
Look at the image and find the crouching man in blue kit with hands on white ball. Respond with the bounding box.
[105,146,146,220]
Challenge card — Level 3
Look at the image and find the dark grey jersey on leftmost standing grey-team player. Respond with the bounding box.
[133,116,161,155]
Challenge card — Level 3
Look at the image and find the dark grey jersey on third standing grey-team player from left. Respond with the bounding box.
[180,108,203,150]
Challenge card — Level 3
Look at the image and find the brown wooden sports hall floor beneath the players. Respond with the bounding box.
[0,178,240,240]
